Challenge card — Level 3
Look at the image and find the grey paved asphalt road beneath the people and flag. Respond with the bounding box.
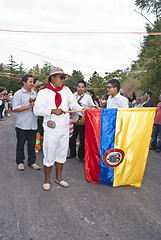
[0,114,161,240]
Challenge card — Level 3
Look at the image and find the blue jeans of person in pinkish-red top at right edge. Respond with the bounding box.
[151,123,161,150]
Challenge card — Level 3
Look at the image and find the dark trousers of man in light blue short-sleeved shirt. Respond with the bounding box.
[16,127,37,166]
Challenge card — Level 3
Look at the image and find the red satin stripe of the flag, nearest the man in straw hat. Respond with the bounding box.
[85,109,101,183]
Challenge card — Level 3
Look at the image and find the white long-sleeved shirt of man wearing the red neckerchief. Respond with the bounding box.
[33,86,82,131]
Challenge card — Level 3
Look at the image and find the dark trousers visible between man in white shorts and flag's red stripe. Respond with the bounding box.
[69,125,85,159]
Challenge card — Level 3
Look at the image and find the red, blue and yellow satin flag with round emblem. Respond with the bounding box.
[85,108,156,187]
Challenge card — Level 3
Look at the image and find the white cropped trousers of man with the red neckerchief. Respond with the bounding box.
[43,127,69,167]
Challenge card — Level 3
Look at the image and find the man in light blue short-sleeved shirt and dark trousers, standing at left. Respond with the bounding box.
[13,75,41,171]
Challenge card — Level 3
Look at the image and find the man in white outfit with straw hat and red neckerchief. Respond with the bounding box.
[33,67,83,190]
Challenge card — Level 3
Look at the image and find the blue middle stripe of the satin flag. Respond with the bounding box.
[100,108,117,186]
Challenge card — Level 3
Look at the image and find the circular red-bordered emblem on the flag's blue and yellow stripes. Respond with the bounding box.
[103,148,125,167]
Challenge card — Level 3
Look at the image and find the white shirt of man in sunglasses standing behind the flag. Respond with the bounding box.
[106,93,129,108]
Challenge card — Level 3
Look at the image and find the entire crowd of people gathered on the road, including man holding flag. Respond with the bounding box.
[0,67,161,190]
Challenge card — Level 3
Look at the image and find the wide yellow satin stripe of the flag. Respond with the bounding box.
[113,108,156,187]
